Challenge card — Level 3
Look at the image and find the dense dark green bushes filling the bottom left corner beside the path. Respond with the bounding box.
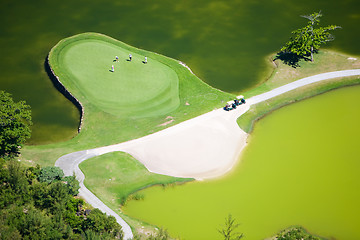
[0,159,123,239]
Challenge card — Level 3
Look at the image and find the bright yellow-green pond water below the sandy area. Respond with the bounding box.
[124,86,360,240]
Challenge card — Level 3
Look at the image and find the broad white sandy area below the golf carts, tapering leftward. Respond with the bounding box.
[88,104,249,180]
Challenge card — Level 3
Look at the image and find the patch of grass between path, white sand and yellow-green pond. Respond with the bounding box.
[80,152,193,206]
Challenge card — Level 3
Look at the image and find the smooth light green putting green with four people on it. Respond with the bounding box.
[58,38,180,117]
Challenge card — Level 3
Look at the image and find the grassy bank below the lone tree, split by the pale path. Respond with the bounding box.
[237,50,360,133]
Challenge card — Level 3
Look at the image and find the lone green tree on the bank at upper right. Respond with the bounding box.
[280,11,341,62]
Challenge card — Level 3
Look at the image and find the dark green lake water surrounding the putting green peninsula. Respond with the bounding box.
[0,0,360,144]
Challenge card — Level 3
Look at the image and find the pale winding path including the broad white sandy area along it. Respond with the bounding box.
[55,69,360,239]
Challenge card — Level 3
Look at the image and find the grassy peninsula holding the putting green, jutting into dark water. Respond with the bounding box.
[21,33,235,166]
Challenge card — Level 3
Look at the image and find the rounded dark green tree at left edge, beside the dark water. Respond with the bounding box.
[0,91,32,157]
